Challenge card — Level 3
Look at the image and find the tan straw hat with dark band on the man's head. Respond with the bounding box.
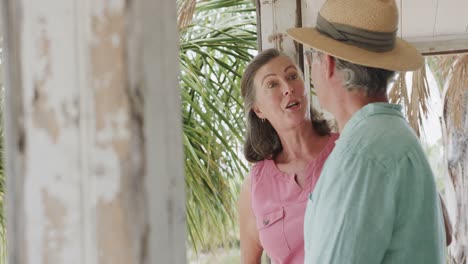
[286,0,423,71]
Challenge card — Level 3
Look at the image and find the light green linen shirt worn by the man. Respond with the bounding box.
[304,103,445,264]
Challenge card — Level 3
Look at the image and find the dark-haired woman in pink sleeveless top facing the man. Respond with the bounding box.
[239,49,338,264]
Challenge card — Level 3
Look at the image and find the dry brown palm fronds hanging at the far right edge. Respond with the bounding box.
[438,54,468,263]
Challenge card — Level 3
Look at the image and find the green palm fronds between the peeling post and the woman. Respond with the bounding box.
[179,0,257,251]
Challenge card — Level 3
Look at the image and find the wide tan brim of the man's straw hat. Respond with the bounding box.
[286,27,424,71]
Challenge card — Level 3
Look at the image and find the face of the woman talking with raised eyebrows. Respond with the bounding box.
[253,56,309,130]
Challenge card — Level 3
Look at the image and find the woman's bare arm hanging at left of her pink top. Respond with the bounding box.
[238,173,263,264]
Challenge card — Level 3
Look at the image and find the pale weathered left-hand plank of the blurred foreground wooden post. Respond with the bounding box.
[4,0,83,263]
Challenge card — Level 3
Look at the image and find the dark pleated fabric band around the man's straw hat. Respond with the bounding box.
[315,13,396,52]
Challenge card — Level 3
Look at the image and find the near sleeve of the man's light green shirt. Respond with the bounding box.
[305,153,396,264]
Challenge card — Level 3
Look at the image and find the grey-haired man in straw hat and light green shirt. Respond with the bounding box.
[287,0,445,264]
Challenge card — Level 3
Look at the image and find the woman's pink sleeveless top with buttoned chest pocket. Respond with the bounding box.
[251,134,338,264]
